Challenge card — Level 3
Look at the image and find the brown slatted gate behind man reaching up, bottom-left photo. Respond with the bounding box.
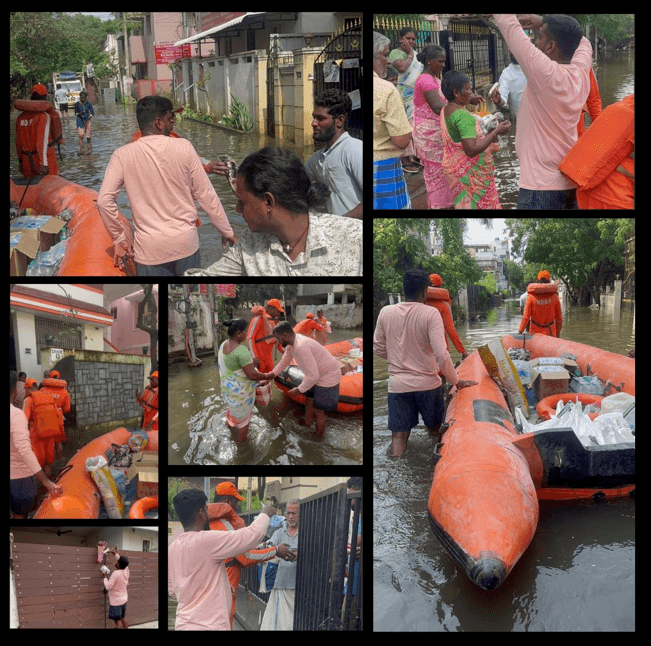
[13,543,158,628]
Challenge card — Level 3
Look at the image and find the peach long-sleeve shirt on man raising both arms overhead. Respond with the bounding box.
[494,14,592,191]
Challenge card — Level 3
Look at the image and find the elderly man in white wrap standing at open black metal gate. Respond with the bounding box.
[260,498,300,630]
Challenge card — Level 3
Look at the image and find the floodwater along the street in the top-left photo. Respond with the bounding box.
[9,103,314,267]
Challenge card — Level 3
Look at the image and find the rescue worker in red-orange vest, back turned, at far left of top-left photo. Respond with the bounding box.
[14,83,65,177]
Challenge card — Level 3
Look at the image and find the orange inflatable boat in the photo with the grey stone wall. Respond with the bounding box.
[34,428,158,518]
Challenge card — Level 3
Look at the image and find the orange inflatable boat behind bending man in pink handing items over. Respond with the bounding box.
[275,338,364,413]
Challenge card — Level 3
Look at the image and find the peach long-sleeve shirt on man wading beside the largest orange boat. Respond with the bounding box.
[373,301,459,393]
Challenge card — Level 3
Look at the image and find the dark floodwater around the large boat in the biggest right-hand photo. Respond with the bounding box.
[373,301,635,632]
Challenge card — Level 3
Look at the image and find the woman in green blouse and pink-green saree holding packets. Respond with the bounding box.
[441,71,511,209]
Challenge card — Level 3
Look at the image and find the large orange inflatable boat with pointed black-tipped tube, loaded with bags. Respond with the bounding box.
[428,334,635,590]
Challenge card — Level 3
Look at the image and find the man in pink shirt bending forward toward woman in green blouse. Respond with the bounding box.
[266,321,341,437]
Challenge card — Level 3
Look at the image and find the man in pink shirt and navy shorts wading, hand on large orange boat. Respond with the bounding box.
[373,269,477,457]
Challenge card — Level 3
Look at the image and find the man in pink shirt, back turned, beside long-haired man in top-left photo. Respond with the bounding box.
[97,96,237,276]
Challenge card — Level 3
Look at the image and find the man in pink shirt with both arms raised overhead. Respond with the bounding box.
[493,14,592,209]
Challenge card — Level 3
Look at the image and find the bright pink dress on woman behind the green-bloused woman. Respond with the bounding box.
[413,72,454,209]
